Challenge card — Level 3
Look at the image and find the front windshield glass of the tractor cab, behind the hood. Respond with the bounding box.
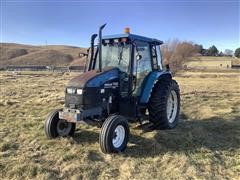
[97,43,130,72]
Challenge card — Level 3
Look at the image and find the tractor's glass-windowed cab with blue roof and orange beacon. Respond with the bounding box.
[88,28,163,100]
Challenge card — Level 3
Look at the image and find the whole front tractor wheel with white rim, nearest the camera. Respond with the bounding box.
[99,115,129,153]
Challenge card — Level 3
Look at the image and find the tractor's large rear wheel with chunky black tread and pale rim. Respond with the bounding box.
[148,79,180,129]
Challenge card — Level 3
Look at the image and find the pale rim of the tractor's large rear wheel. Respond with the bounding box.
[167,90,178,123]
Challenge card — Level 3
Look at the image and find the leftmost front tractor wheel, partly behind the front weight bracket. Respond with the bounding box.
[44,109,76,139]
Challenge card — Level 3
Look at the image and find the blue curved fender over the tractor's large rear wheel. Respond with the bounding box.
[139,71,172,104]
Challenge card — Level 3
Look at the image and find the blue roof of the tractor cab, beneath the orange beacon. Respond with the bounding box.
[102,33,163,45]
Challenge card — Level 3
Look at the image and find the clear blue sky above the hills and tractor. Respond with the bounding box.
[1,0,240,51]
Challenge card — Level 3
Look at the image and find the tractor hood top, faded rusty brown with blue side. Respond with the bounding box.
[67,68,119,88]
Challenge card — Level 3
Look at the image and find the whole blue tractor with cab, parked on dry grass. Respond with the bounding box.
[45,24,180,153]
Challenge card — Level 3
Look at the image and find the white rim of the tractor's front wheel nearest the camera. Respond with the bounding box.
[112,125,125,148]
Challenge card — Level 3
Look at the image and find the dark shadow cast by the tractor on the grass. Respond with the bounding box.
[70,114,240,158]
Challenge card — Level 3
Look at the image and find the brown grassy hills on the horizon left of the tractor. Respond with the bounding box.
[0,43,87,67]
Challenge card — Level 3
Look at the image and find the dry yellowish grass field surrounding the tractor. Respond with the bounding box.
[0,72,240,179]
